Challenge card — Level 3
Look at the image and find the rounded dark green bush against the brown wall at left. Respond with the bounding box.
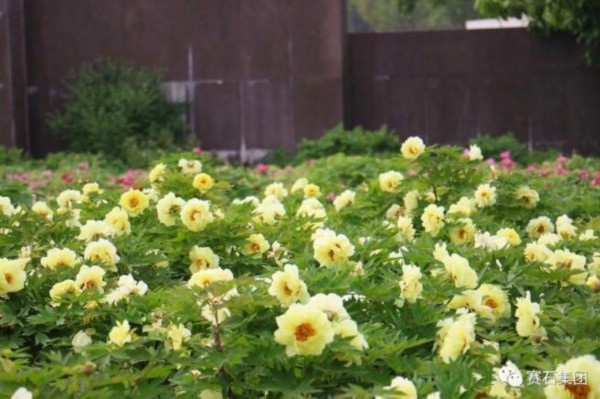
[49,60,186,166]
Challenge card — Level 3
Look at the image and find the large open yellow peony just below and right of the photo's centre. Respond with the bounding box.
[313,229,354,267]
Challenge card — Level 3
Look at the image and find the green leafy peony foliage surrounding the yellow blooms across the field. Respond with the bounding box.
[0,144,600,399]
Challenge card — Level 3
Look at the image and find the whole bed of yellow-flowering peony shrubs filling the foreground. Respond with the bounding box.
[0,138,600,399]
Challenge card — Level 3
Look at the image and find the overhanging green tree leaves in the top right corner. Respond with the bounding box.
[475,0,600,64]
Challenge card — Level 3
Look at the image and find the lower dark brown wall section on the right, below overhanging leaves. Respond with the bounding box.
[346,29,600,154]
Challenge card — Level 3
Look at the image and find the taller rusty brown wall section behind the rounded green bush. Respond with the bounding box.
[21,0,343,159]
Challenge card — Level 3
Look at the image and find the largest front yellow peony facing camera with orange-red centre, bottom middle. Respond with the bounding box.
[275,304,334,357]
